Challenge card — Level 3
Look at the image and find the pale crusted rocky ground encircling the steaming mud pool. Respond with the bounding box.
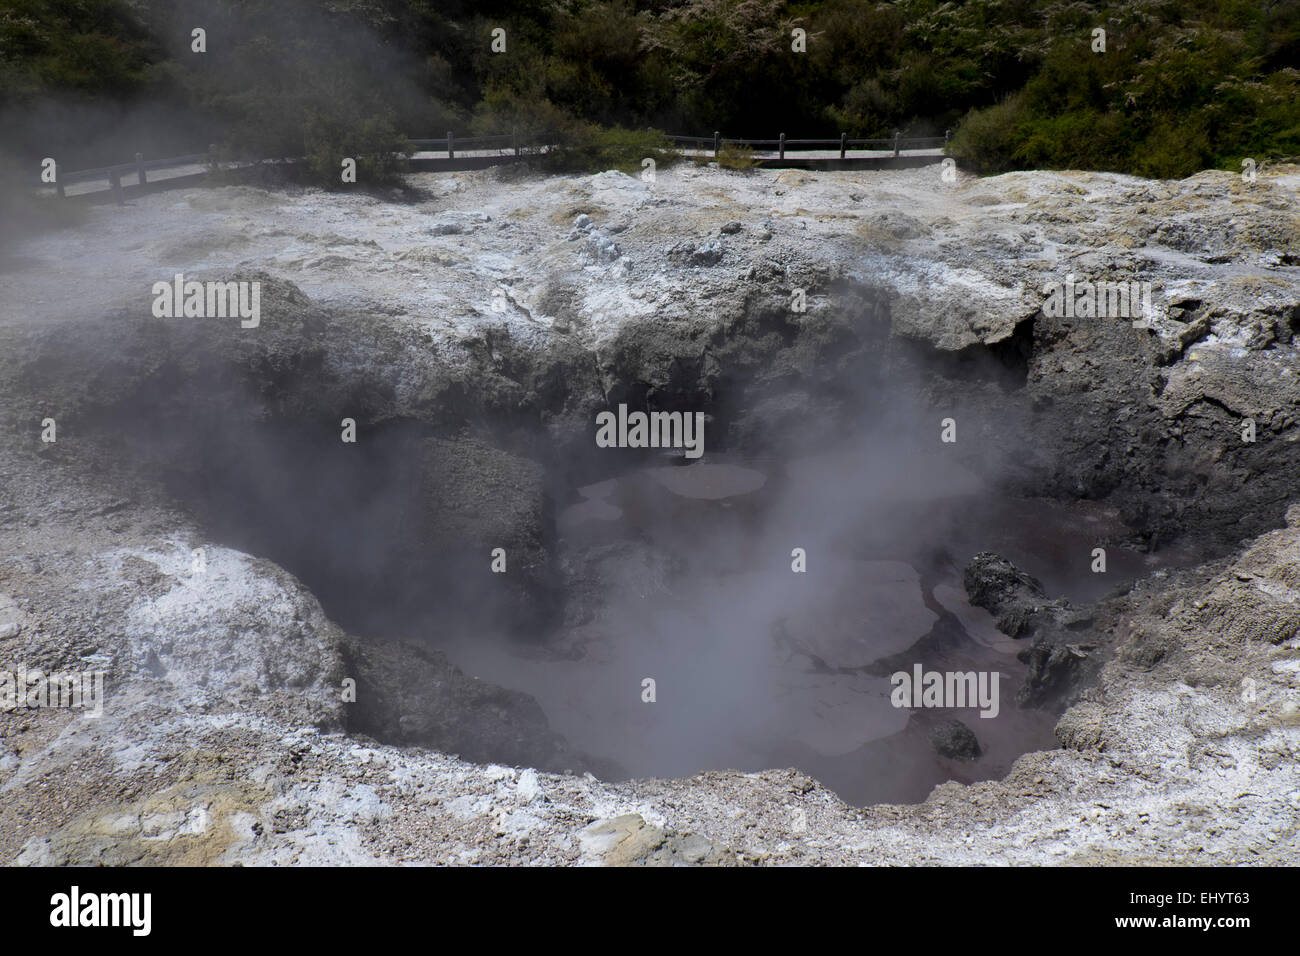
[0,160,1300,864]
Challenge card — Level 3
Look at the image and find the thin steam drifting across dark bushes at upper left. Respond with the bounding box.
[0,0,455,170]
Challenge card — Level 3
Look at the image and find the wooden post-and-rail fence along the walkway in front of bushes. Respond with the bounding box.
[45,131,952,204]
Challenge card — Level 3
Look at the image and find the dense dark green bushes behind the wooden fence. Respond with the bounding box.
[0,0,1300,177]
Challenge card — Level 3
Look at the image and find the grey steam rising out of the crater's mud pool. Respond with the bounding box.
[5,204,1093,803]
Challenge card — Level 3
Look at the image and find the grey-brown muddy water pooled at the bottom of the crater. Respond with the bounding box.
[447,451,1190,804]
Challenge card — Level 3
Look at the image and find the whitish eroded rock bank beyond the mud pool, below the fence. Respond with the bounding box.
[12,166,1300,548]
